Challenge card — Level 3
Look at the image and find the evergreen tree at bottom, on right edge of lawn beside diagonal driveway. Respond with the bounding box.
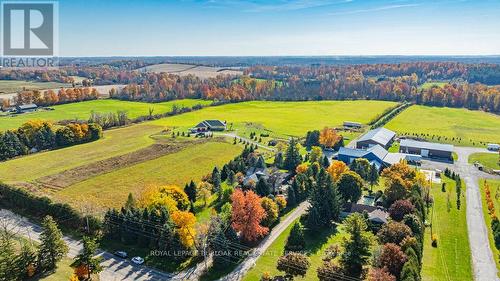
[340,213,372,278]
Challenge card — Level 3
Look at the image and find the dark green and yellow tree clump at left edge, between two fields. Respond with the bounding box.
[0,120,102,161]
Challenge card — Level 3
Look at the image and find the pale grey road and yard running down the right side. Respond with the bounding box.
[422,147,500,281]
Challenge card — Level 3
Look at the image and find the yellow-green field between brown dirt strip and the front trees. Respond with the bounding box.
[53,142,242,210]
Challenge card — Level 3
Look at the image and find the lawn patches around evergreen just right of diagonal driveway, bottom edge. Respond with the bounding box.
[243,219,345,281]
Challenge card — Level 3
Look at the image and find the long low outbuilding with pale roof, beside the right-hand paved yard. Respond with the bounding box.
[399,139,453,160]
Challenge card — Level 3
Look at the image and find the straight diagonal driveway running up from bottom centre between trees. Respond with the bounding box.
[219,202,310,281]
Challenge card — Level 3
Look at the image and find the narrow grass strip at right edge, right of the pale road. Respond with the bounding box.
[479,180,500,274]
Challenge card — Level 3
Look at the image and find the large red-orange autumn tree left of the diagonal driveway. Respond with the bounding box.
[231,189,269,243]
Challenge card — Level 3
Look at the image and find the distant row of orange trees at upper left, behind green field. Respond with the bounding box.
[15,87,99,106]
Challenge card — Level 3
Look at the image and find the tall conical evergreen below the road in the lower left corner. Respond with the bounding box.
[38,216,68,271]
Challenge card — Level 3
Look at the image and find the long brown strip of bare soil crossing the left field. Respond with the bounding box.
[33,139,207,190]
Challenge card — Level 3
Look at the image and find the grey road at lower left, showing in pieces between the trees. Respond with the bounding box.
[0,209,193,281]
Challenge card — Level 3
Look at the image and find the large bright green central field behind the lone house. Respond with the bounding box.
[153,101,396,137]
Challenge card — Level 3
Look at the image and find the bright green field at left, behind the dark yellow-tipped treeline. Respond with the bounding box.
[0,99,211,131]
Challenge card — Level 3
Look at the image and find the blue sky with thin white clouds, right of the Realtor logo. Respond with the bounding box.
[55,0,500,56]
